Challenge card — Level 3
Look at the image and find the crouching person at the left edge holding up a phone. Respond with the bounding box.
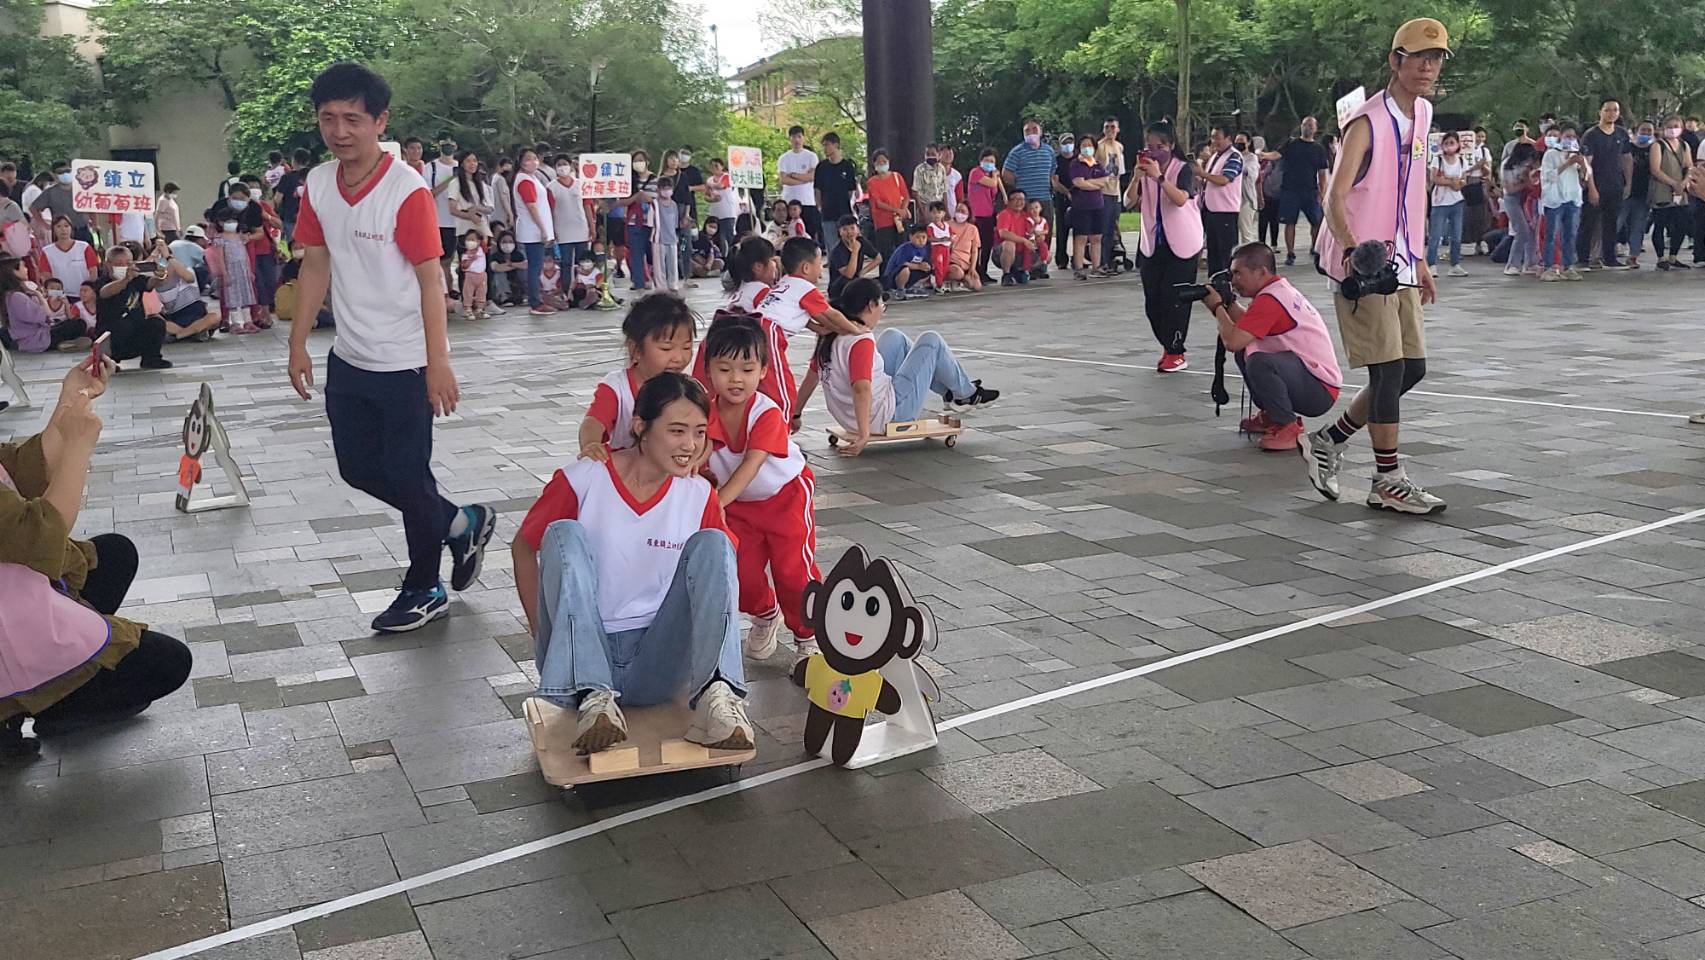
[0,358,191,760]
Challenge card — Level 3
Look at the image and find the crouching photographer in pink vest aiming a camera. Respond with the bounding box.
[1202,244,1344,450]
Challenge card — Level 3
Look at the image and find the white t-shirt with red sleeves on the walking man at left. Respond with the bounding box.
[293,153,443,373]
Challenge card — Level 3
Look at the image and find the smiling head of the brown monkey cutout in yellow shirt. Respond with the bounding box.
[805,546,924,674]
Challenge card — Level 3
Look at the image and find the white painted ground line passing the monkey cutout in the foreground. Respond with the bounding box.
[138,508,1705,960]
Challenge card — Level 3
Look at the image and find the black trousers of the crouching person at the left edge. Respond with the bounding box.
[36,534,191,737]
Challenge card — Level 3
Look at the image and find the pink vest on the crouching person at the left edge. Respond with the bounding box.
[0,467,113,697]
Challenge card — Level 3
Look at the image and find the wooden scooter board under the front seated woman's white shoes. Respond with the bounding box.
[523,697,757,786]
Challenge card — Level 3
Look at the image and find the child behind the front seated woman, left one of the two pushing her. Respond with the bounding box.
[580,290,696,460]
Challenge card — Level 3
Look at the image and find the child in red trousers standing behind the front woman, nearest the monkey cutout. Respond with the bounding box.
[704,317,822,660]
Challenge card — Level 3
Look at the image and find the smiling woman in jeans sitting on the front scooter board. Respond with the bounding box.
[513,373,752,754]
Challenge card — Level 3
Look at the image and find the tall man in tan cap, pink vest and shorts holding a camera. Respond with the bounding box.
[1301,17,1451,513]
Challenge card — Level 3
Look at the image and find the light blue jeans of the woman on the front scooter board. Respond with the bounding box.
[534,520,745,708]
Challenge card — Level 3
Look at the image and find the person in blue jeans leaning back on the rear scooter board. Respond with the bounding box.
[800,280,1001,457]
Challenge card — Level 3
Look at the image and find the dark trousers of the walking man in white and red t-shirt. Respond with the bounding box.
[326,353,455,588]
